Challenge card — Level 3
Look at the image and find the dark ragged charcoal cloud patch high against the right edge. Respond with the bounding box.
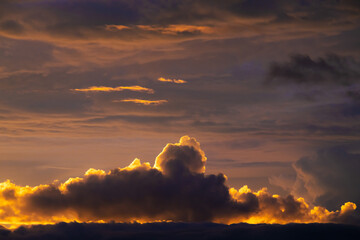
[266,54,360,85]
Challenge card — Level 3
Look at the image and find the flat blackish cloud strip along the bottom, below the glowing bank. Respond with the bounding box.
[0,223,360,240]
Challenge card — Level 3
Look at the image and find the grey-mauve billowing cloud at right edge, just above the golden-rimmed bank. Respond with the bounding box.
[294,147,360,208]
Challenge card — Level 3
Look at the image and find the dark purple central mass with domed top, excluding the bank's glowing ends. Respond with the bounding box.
[26,137,258,221]
